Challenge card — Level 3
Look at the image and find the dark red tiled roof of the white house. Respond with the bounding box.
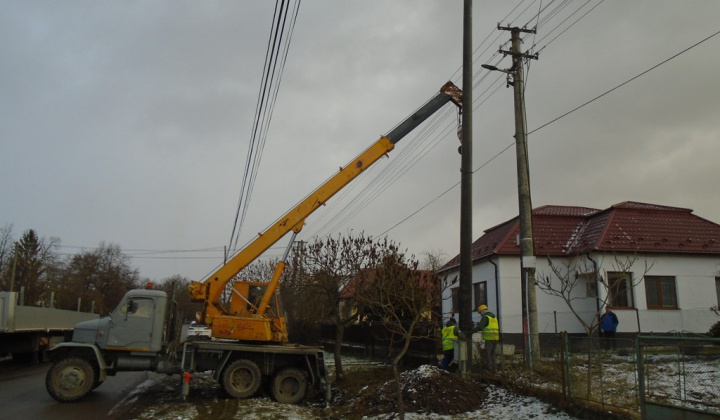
[440,201,720,271]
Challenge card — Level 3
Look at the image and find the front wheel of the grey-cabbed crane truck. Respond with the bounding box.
[45,357,95,402]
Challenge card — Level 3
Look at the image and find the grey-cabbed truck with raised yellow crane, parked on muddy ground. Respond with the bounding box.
[45,82,462,403]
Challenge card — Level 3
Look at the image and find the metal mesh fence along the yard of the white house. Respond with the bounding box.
[472,333,720,419]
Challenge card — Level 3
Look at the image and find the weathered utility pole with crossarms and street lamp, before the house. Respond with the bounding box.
[482,25,540,367]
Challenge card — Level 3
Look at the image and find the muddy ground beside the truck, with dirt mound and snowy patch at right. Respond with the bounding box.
[108,362,596,420]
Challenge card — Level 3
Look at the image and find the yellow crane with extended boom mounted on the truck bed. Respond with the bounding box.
[189,82,462,342]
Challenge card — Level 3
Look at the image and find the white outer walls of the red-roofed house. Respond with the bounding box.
[443,254,720,333]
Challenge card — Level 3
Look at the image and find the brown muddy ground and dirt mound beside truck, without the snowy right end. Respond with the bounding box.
[111,365,485,420]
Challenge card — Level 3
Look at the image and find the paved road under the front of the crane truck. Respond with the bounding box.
[0,363,147,420]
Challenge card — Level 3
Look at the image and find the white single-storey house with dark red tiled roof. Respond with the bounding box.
[439,202,720,333]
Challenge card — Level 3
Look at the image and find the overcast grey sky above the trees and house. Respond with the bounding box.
[0,0,720,280]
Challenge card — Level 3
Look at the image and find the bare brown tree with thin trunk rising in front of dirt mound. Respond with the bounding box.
[355,246,440,419]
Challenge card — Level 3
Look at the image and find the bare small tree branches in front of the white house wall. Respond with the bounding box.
[536,254,653,336]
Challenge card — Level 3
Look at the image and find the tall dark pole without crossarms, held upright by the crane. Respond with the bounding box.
[458,0,473,375]
